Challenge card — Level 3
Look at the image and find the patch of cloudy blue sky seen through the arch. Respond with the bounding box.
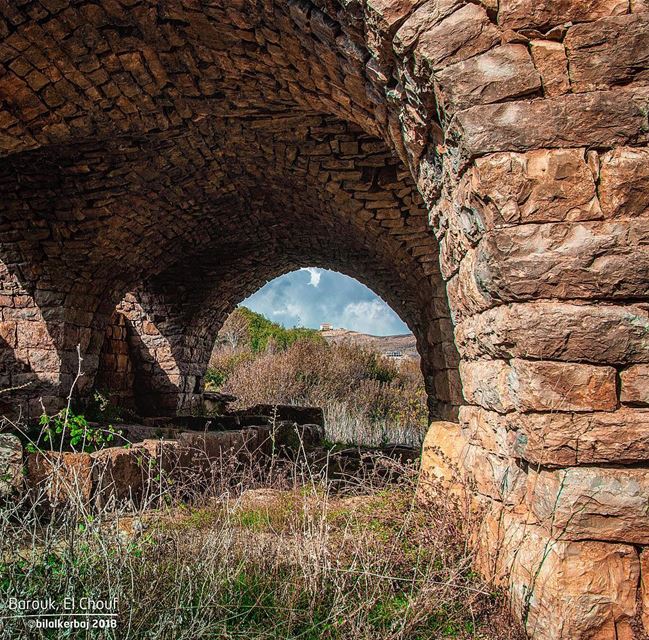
[241,267,409,336]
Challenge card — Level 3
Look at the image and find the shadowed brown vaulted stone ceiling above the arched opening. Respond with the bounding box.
[0,1,459,418]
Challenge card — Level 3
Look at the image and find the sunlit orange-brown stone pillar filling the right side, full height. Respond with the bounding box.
[366,0,649,640]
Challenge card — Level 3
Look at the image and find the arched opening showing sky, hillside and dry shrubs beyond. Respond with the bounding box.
[204,267,428,448]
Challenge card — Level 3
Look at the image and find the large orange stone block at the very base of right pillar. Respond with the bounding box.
[479,508,640,640]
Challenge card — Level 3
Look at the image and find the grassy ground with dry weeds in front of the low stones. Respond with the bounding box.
[0,462,520,640]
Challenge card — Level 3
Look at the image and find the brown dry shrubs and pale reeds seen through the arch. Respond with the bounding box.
[218,341,428,445]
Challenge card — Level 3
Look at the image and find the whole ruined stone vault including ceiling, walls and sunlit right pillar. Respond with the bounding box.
[0,0,649,640]
